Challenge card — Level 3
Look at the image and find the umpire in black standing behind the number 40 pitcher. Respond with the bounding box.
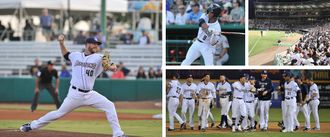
[31,61,61,112]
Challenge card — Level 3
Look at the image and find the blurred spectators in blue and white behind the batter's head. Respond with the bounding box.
[166,0,245,25]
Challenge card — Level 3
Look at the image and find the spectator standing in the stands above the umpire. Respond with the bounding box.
[40,9,53,41]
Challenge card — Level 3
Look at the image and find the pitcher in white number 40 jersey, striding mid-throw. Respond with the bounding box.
[19,35,126,137]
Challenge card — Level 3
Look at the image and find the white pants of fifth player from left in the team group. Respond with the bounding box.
[231,98,246,125]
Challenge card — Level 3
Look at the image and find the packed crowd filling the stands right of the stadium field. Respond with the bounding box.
[281,24,330,66]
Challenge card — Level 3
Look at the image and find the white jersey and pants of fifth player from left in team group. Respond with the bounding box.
[232,81,246,131]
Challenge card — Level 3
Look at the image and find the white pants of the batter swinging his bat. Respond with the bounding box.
[181,40,215,66]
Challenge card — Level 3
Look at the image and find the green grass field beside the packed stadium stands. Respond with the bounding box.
[249,31,285,56]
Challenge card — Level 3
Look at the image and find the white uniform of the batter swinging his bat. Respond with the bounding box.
[181,14,221,66]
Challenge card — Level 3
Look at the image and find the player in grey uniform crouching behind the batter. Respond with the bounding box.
[214,35,229,65]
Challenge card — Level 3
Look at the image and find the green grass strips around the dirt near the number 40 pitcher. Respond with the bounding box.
[0,104,162,137]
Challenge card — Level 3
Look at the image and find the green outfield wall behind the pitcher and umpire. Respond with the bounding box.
[0,78,162,103]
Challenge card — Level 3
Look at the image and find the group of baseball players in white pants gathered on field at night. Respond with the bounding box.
[167,71,320,132]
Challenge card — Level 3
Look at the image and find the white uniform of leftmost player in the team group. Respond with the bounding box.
[167,80,184,129]
